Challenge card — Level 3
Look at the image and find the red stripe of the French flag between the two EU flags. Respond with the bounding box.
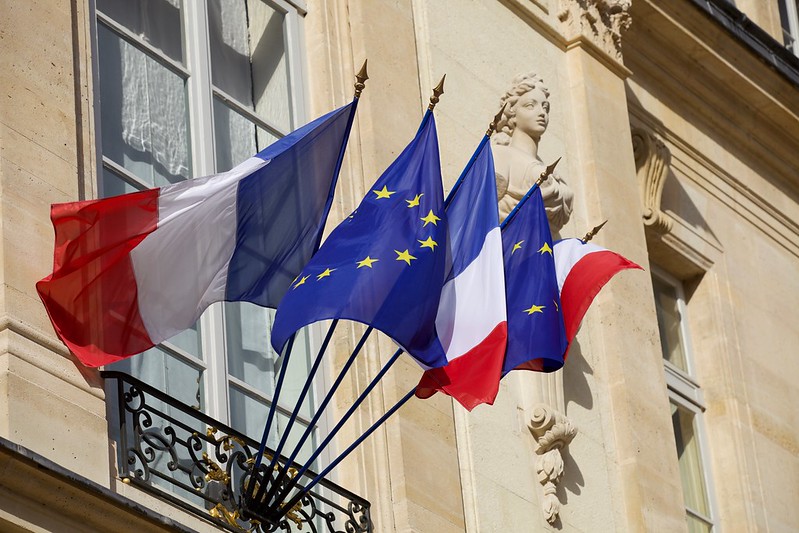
[416,322,508,411]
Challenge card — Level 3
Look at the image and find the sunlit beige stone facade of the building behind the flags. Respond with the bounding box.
[0,0,799,533]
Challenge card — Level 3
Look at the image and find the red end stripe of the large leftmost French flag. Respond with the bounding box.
[36,189,159,367]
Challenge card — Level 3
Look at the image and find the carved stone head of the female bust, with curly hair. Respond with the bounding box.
[495,72,549,144]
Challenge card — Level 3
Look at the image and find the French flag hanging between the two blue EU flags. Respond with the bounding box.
[416,137,508,411]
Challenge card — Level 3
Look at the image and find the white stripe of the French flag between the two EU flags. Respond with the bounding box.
[436,228,507,361]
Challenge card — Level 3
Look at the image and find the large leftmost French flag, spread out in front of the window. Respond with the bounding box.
[36,100,357,366]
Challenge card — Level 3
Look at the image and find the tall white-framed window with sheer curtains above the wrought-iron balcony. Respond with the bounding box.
[96,0,312,458]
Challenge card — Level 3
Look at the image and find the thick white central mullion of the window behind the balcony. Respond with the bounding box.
[183,0,230,423]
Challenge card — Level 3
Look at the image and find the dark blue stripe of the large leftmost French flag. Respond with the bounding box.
[225,103,354,307]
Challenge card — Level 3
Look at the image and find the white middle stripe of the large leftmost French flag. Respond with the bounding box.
[131,157,268,343]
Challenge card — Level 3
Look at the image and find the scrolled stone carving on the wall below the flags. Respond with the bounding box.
[530,404,577,524]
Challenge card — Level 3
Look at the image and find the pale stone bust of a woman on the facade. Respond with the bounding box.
[493,73,574,232]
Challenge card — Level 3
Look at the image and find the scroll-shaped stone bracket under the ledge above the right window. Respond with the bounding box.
[631,127,672,235]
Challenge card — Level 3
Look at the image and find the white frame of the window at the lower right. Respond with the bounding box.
[652,265,718,531]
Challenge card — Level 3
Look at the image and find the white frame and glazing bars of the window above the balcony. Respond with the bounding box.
[89,0,330,454]
